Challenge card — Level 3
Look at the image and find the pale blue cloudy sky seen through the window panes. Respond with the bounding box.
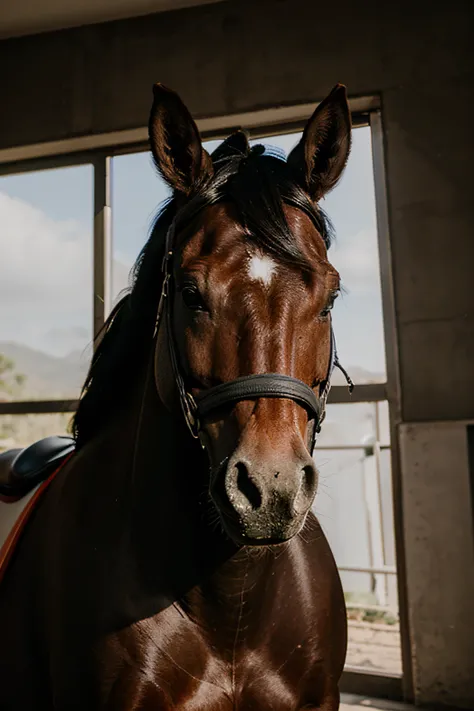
[0,127,385,379]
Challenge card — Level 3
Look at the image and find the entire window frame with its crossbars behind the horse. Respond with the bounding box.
[0,95,413,700]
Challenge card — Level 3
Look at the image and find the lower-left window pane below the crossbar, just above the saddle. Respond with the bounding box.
[0,412,72,452]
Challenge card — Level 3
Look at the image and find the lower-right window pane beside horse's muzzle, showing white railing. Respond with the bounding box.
[313,403,401,674]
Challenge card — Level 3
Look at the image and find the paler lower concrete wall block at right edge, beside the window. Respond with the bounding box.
[400,422,474,709]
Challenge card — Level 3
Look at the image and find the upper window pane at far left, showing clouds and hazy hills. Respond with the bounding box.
[0,165,93,400]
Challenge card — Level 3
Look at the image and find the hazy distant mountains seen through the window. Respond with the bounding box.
[0,341,384,399]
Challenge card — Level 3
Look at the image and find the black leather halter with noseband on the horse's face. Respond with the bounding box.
[155,222,354,454]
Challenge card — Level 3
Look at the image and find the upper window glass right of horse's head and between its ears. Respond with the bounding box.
[254,126,386,385]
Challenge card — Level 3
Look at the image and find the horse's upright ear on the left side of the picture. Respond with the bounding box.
[148,84,213,195]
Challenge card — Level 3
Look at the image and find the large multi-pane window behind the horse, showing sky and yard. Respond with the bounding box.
[0,104,401,675]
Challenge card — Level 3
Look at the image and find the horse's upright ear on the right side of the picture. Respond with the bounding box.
[288,84,351,202]
